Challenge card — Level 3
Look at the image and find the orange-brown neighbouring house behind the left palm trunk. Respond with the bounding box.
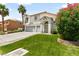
[0,19,23,31]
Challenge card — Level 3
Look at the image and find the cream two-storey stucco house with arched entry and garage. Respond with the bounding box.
[24,12,56,33]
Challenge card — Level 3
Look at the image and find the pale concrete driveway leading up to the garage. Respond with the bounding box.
[0,32,38,46]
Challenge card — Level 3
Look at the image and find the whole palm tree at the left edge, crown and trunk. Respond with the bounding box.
[0,4,9,32]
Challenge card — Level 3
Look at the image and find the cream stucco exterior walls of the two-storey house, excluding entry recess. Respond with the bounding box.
[25,12,56,32]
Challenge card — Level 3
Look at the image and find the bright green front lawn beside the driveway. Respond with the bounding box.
[0,34,79,56]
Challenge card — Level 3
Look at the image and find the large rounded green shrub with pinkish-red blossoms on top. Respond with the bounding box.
[56,3,79,41]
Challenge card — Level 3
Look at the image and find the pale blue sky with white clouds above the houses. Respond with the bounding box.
[0,3,67,21]
